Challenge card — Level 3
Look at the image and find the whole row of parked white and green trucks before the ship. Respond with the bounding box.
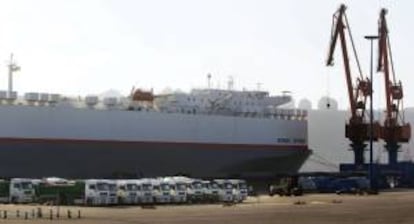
[0,176,248,206]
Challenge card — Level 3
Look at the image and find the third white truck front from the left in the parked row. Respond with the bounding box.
[116,180,140,205]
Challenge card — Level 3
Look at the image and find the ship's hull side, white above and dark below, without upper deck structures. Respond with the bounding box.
[0,105,310,177]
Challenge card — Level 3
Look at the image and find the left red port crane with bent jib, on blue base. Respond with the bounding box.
[326,4,379,165]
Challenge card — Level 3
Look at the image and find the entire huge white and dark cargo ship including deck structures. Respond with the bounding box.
[0,59,311,178]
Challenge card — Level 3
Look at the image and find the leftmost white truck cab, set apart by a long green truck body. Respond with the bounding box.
[9,178,35,203]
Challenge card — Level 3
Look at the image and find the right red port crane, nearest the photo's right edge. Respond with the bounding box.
[377,9,411,165]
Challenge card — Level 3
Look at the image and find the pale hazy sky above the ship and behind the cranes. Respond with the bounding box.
[0,0,414,108]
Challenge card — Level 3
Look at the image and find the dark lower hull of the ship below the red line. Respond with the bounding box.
[0,138,311,178]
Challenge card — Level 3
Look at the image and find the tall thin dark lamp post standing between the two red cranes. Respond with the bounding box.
[364,35,378,190]
